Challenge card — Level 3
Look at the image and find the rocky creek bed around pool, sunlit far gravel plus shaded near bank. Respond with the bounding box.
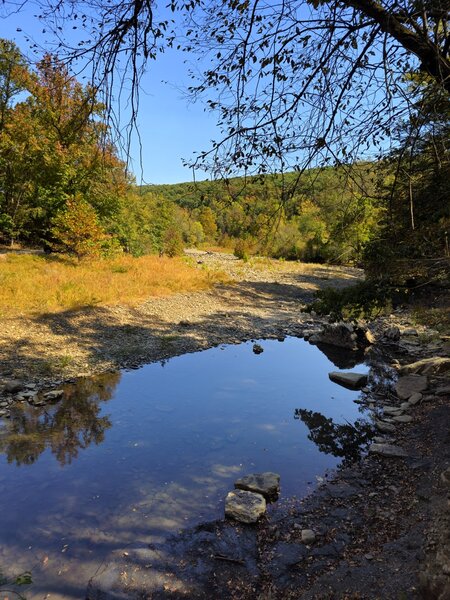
[0,253,450,600]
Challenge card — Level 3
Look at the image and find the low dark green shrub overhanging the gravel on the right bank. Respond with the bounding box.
[306,281,407,321]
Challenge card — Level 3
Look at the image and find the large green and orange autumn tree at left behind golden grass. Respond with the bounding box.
[0,49,130,244]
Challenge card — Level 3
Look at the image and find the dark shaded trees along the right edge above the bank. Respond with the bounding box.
[363,81,450,285]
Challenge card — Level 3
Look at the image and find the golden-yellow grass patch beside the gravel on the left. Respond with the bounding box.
[0,254,225,317]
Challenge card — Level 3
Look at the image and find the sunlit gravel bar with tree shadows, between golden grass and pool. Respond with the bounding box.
[0,250,362,384]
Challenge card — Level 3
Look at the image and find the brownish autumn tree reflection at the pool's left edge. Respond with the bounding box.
[0,373,120,465]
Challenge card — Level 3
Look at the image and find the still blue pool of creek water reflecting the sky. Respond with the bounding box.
[0,338,370,599]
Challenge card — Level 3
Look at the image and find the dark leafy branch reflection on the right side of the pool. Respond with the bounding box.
[294,408,373,463]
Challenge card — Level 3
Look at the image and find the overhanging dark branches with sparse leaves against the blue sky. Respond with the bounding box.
[14,0,450,175]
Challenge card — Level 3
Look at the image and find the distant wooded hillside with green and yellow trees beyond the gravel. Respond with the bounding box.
[143,164,379,262]
